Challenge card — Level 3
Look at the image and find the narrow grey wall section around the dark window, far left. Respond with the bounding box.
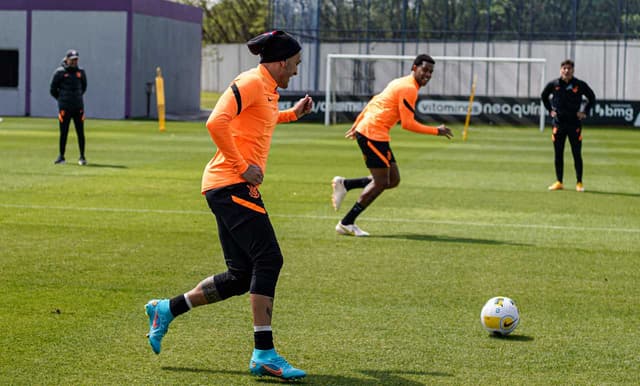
[0,11,27,116]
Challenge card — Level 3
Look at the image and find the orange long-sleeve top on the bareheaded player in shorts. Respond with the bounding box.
[353,74,438,142]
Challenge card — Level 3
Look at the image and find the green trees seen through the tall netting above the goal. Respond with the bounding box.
[270,0,640,41]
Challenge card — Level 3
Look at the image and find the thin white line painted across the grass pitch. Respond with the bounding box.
[0,204,640,233]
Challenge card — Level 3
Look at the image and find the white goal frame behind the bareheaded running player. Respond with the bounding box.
[324,54,547,131]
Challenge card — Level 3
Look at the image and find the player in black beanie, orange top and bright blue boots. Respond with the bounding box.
[145,31,313,380]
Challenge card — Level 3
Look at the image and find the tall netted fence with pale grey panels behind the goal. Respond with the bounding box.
[220,0,640,100]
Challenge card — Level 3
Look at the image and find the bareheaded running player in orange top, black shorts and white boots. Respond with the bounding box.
[331,54,453,236]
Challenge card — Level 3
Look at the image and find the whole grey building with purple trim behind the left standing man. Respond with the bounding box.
[0,0,202,119]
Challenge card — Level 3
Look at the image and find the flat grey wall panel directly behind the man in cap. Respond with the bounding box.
[31,11,127,118]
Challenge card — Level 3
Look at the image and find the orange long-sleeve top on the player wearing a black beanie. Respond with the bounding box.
[202,64,297,194]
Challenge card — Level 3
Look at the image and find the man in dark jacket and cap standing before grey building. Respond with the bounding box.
[50,50,87,165]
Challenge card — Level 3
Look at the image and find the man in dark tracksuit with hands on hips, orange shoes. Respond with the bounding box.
[541,59,596,192]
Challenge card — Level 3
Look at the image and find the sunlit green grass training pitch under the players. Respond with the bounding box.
[0,118,640,385]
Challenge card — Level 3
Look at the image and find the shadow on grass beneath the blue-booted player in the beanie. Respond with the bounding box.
[162,366,452,386]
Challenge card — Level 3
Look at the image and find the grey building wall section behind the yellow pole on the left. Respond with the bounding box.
[131,14,202,117]
